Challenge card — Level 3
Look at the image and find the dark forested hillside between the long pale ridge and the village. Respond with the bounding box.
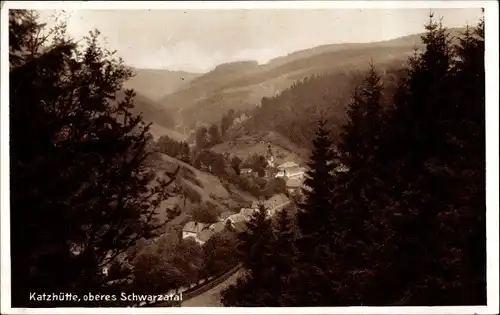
[240,61,404,152]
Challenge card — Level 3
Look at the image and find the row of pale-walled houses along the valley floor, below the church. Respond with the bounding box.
[182,194,290,245]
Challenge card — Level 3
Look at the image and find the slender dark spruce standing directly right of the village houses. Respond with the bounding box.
[292,120,344,306]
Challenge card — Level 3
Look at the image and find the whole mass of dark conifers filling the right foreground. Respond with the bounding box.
[223,16,486,306]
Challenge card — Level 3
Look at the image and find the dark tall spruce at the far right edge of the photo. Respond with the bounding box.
[434,17,486,305]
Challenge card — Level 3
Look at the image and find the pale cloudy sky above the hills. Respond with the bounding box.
[37,8,481,72]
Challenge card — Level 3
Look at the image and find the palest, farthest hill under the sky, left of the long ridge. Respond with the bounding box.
[124,68,202,101]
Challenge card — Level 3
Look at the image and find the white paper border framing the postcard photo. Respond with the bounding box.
[0,1,499,314]
